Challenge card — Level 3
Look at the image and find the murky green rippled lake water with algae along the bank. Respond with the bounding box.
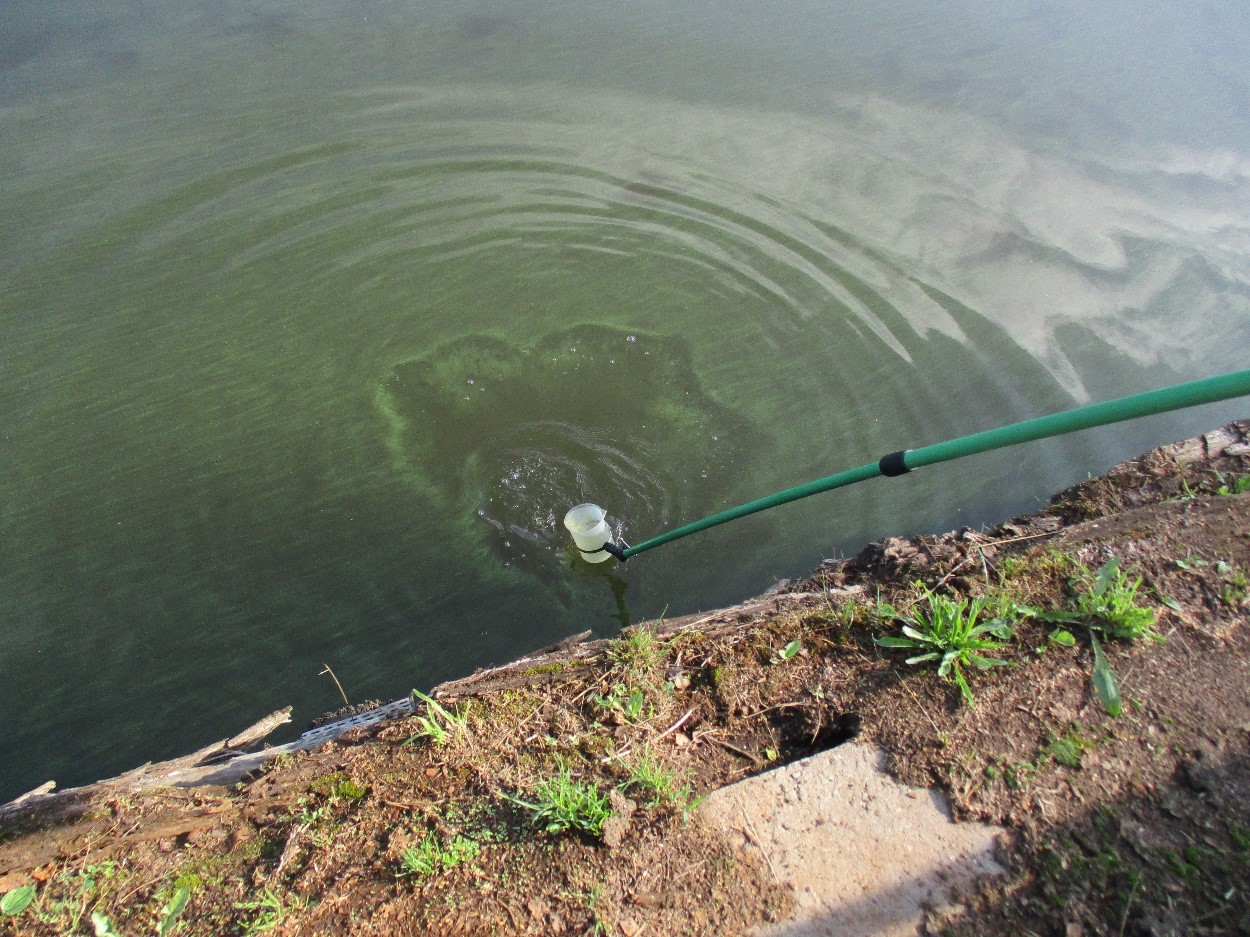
[0,0,1250,798]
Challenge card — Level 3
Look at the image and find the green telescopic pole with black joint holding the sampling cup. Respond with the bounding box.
[618,370,1250,560]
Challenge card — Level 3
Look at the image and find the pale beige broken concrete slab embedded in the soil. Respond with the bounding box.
[700,743,1004,937]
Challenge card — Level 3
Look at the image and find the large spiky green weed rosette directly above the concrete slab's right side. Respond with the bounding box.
[873,582,1013,706]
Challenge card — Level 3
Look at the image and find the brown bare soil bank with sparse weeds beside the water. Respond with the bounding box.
[0,422,1250,937]
